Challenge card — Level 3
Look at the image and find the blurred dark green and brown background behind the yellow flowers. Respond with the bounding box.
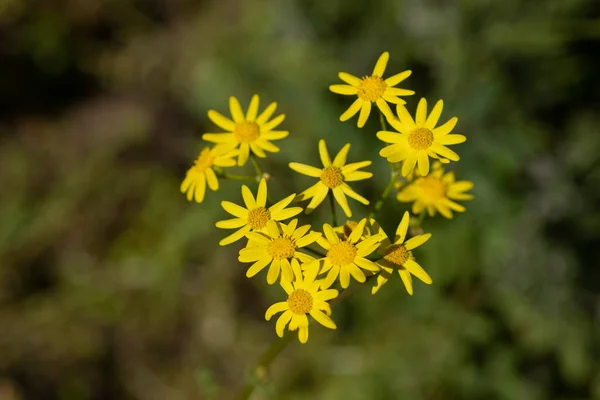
[0,0,600,400]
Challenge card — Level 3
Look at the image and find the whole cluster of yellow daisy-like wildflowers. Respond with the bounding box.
[181,52,473,343]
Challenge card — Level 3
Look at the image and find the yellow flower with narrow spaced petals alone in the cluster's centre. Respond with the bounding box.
[289,139,373,217]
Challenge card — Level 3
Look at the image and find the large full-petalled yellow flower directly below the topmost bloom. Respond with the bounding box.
[377,99,467,176]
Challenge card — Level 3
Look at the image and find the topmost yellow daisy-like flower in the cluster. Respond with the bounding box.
[329,51,415,128]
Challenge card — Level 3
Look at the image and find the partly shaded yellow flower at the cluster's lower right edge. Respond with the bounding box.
[371,211,432,296]
